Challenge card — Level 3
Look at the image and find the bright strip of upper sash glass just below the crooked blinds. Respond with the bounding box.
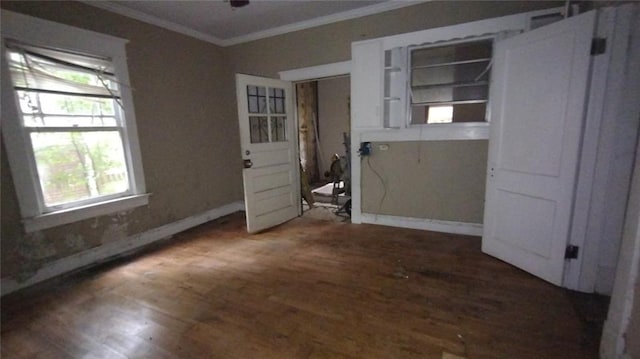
[16,91,117,116]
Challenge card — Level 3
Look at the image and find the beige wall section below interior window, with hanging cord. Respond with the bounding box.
[362,140,488,223]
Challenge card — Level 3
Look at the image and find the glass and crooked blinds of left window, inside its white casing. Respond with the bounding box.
[7,42,132,210]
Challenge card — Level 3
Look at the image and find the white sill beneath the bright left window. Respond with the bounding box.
[23,193,150,233]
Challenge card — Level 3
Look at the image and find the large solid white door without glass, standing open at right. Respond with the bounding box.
[482,11,596,285]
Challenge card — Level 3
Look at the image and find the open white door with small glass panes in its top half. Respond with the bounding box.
[236,74,300,233]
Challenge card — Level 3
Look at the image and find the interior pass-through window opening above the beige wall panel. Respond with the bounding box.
[410,39,493,124]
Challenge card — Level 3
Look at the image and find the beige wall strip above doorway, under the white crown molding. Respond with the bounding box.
[226,1,564,77]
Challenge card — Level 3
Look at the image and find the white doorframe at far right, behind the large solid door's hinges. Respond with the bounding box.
[564,7,638,295]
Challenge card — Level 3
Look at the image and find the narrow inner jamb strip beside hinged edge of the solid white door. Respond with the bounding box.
[563,8,624,294]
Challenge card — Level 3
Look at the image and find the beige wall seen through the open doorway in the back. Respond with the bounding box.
[318,77,351,180]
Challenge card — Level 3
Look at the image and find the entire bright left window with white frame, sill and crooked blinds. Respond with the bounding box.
[2,11,147,231]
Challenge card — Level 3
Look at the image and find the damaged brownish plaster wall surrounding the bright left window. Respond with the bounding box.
[0,1,243,281]
